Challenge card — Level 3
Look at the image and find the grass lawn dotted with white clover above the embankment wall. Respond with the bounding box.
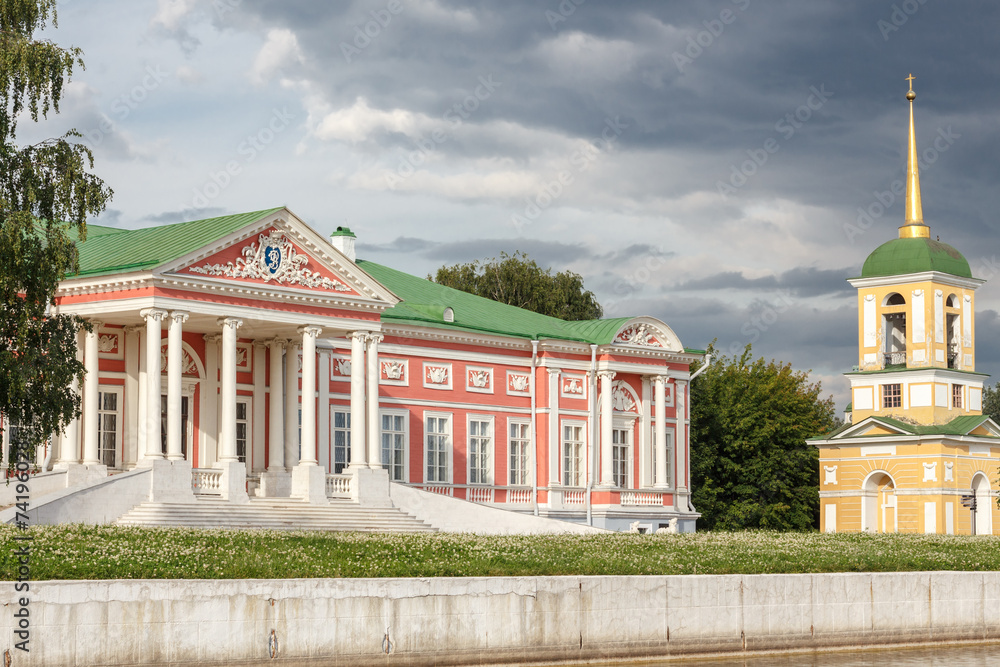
[0,525,1000,581]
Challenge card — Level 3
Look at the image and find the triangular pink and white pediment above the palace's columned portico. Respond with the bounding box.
[157,209,399,306]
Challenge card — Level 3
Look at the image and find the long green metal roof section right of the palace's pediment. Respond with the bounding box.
[358,260,632,345]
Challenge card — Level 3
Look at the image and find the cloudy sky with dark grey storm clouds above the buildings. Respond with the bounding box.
[25,0,1000,408]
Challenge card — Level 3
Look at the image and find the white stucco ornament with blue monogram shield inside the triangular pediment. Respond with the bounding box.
[191,229,350,292]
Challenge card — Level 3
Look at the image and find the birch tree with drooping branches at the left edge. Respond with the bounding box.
[0,0,111,462]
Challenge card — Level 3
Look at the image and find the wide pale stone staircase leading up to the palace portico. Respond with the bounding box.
[115,498,435,533]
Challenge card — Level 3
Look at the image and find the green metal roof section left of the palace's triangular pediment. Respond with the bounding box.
[75,211,282,276]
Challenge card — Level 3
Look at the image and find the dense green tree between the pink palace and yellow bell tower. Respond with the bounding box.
[691,345,835,530]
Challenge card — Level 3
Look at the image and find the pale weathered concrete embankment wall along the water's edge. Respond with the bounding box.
[0,572,1000,667]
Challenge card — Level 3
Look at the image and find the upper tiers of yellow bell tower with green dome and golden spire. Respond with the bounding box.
[848,74,985,424]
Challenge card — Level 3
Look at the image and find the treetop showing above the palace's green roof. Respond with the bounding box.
[427,251,604,320]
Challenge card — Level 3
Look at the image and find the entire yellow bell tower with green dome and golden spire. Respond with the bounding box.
[809,75,1000,535]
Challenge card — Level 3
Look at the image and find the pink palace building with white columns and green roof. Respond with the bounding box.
[4,208,704,531]
